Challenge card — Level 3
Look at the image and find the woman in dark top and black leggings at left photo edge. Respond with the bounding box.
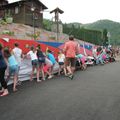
[0,44,9,96]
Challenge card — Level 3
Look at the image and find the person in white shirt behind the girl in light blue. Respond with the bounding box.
[12,43,23,84]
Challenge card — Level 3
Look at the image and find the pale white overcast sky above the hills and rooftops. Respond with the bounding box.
[8,0,120,24]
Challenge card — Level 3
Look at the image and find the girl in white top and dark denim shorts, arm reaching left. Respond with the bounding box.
[27,46,41,82]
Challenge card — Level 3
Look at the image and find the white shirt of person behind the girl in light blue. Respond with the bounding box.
[13,47,22,66]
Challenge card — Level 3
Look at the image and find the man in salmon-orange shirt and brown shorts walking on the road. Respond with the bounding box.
[63,35,79,79]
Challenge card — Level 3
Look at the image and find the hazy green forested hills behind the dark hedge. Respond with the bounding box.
[44,19,120,44]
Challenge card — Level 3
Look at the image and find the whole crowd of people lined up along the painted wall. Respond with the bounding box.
[0,36,118,96]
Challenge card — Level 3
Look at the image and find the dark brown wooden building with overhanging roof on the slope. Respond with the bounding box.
[0,0,47,27]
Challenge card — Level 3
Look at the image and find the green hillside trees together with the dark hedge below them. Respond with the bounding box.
[43,19,120,45]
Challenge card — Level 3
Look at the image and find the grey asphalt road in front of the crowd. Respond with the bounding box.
[0,62,120,120]
